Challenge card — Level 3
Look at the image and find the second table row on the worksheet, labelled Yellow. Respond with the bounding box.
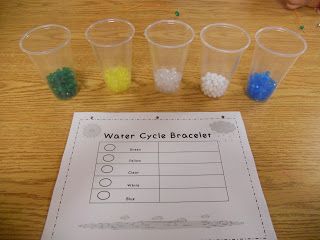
[96,152,221,164]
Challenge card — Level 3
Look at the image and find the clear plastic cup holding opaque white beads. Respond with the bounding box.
[200,23,251,98]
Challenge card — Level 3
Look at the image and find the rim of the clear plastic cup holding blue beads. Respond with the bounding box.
[255,26,308,57]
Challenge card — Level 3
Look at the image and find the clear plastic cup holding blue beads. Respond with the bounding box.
[246,27,307,101]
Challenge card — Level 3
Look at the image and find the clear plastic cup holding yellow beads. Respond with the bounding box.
[85,19,135,93]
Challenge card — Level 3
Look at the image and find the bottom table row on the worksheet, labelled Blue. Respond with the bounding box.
[90,188,229,203]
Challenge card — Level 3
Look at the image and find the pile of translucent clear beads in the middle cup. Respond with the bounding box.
[154,68,182,93]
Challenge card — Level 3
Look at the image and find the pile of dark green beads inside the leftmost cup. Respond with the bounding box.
[47,67,78,100]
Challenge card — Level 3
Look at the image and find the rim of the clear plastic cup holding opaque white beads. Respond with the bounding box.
[200,23,251,53]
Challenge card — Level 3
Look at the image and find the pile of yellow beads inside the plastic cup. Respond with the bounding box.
[103,66,131,93]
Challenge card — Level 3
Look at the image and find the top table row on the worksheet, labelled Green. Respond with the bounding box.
[98,141,219,153]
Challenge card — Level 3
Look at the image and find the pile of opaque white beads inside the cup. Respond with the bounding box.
[201,72,229,98]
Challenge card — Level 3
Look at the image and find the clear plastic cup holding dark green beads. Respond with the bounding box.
[20,24,79,100]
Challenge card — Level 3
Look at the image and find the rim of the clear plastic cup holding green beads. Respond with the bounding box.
[19,24,71,55]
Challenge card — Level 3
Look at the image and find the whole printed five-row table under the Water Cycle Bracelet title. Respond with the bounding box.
[89,141,229,203]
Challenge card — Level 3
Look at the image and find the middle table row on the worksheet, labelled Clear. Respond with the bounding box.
[95,163,223,176]
